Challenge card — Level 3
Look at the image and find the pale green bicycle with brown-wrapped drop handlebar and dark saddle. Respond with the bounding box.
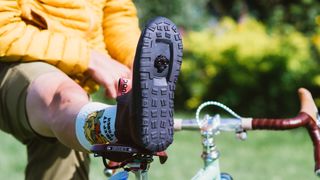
[92,89,320,180]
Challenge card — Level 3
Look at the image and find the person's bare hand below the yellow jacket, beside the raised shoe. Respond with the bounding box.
[88,50,131,98]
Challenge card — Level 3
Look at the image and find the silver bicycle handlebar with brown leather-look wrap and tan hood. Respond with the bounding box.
[174,88,320,176]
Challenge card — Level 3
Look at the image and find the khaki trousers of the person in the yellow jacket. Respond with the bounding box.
[0,62,90,180]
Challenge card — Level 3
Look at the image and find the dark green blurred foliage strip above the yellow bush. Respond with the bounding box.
[135,0,320,33]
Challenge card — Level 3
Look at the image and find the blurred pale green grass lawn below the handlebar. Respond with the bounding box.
[0,126,317,180]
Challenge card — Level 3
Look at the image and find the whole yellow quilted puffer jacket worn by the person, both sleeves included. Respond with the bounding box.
[0,0,140,91]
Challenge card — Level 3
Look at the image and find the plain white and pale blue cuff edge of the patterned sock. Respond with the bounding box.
[75,102,116,151]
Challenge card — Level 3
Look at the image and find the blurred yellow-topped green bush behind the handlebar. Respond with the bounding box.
[176,18,320,117]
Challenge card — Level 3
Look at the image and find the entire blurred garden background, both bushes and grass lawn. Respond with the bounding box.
[0,0,320,180]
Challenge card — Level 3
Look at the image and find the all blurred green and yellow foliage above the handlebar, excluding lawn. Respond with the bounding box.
[135,0,320,117]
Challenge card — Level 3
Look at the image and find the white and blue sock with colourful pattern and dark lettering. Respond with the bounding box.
[75,102,117,151]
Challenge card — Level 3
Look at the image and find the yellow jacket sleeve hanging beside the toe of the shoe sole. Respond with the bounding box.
[103,0,140,66]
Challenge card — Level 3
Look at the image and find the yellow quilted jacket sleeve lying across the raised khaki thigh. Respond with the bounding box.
[0,0,90,75]
